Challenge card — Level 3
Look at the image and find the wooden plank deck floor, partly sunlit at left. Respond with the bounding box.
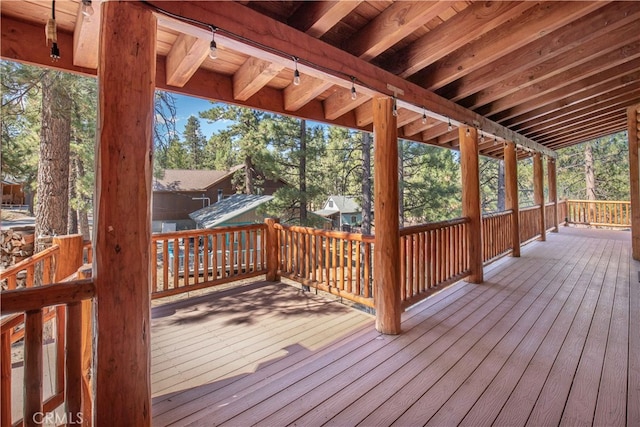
[152,228,640,426]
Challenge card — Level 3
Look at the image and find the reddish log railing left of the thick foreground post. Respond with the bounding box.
[0,235,93,427]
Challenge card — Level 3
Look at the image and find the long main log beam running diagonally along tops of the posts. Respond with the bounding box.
[149,0,555,156]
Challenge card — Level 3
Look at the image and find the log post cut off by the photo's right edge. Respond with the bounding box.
[627,104,640,260]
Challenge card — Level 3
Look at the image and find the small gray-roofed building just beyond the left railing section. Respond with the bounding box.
[189,194,273,228]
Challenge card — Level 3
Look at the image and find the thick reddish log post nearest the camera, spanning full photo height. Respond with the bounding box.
[93,1,157,426]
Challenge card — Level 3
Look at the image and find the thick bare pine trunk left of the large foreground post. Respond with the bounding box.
[36,71,71,251]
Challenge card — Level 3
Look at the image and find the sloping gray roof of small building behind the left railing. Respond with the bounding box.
[189,194,273,228]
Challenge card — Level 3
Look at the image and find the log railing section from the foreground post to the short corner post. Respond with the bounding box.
[151,224,266,298]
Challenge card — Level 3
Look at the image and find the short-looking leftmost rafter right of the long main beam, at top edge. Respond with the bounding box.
[288,0,362,38]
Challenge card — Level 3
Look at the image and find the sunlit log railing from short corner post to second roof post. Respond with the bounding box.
[273,224,374,307]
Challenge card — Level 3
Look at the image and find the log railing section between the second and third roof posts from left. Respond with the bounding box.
[400,218,469,308]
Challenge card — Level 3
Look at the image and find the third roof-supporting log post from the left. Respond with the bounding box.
[458,126,484,283]
